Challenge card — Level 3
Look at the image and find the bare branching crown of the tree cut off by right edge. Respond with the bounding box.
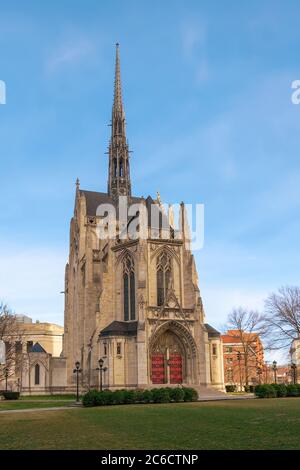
[265,286,300,349]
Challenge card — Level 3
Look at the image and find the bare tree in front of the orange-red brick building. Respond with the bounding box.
[227,307,267,386]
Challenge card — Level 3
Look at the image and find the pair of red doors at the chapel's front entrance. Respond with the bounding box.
[151,354,182,384]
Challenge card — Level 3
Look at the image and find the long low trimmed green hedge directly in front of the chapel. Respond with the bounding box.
[82,387,198,407]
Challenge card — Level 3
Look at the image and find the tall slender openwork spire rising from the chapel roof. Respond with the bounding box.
[108,43,131,198]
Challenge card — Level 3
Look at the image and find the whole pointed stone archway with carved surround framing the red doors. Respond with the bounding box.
[149,321,198,385]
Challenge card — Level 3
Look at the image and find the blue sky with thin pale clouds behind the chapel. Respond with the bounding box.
[0,0,300,352]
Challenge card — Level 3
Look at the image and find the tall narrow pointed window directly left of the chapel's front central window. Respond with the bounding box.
[123,254,135,321]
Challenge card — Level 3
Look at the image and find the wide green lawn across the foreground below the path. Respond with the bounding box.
[0,398,300,450]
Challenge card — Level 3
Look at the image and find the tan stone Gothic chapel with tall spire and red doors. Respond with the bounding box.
[62,44,224,394]
